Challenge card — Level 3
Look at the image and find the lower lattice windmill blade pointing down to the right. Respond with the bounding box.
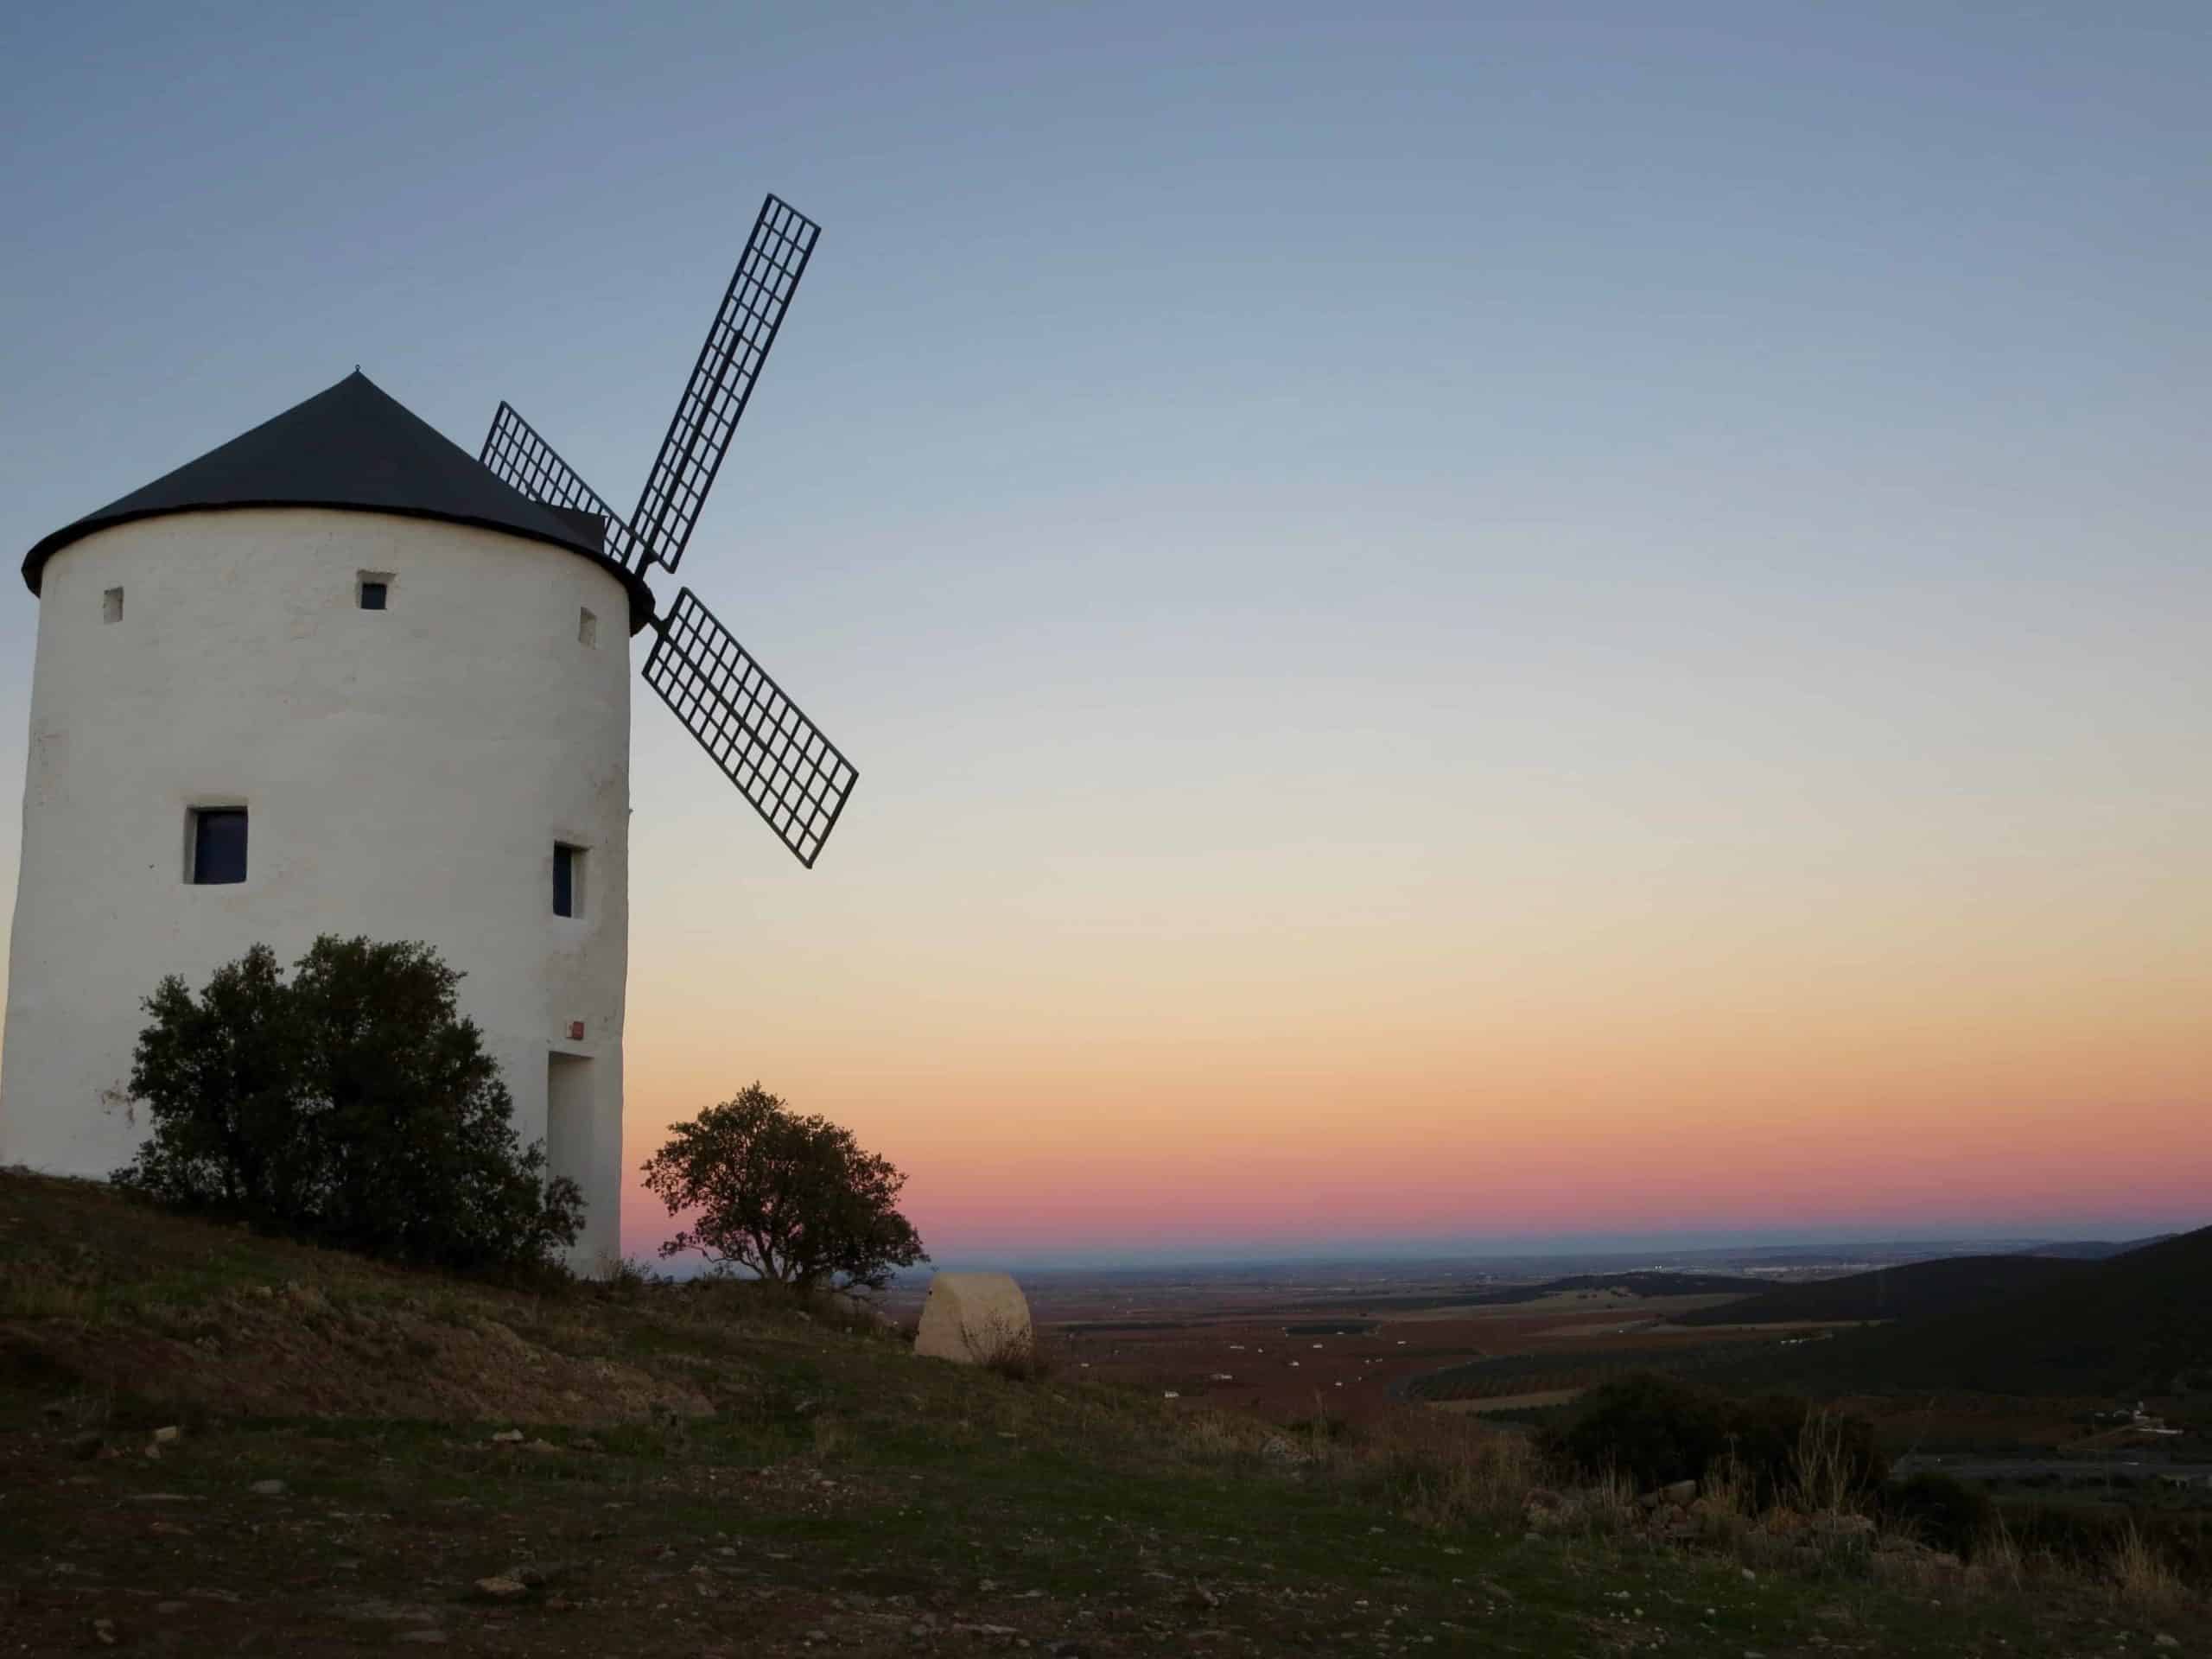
[646,588,861,869]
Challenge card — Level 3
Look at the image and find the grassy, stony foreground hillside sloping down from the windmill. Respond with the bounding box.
[0,1173,2212,1659]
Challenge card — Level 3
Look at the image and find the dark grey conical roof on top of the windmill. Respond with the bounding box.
[22,370,652,632]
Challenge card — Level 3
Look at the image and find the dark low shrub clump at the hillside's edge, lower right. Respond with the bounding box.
[1553,1371,1885,1509]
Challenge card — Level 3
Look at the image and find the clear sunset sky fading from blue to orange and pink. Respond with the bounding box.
[0,0,2212,1263]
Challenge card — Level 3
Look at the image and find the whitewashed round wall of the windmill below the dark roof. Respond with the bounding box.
[0,509,631,1261]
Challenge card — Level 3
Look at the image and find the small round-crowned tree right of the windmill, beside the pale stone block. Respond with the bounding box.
[644,1084,929,1289]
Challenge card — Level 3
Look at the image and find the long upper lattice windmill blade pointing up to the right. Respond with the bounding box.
[631,194,821,575]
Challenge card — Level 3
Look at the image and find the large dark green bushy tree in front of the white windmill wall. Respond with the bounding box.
[115,936,584,1268]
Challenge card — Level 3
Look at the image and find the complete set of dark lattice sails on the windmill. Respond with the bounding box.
[478,193,858,869]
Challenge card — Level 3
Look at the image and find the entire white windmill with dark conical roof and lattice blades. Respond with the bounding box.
[0,197,856,1261]
